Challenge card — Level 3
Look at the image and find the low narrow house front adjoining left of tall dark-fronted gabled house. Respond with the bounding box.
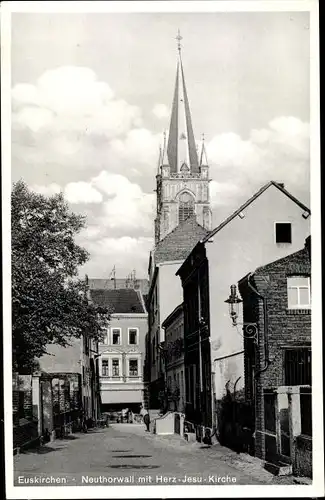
[162,304,186,413]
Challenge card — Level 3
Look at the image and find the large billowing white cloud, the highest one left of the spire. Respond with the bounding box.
[12,66,141,138]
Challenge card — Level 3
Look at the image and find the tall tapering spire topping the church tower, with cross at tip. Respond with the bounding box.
[167,31,199,173]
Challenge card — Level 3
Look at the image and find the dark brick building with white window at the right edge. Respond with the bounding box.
[238,237,311,462]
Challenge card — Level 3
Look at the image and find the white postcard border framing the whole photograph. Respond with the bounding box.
[1,0,324,499]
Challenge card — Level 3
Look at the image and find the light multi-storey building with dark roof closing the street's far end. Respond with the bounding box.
[90,289,148,412]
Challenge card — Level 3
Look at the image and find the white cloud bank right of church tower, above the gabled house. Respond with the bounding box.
[207,116,310,199]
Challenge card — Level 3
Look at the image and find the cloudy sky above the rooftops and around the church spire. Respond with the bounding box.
[11,12,310,278]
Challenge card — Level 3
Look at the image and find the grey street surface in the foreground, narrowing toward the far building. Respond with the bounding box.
[14,424,292,486]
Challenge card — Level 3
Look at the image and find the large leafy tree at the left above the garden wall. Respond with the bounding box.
[11,181,108,373]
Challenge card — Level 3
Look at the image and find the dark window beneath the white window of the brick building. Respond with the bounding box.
[284,347,311,385]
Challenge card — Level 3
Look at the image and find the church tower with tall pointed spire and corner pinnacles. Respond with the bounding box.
[155,33,211,245]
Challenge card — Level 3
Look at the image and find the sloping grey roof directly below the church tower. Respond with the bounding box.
[154,215,209,264]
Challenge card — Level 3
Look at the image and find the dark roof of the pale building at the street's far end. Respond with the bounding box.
[90,288,146,314]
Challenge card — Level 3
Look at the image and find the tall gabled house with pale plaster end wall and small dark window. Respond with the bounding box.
[177,182,310,432]
